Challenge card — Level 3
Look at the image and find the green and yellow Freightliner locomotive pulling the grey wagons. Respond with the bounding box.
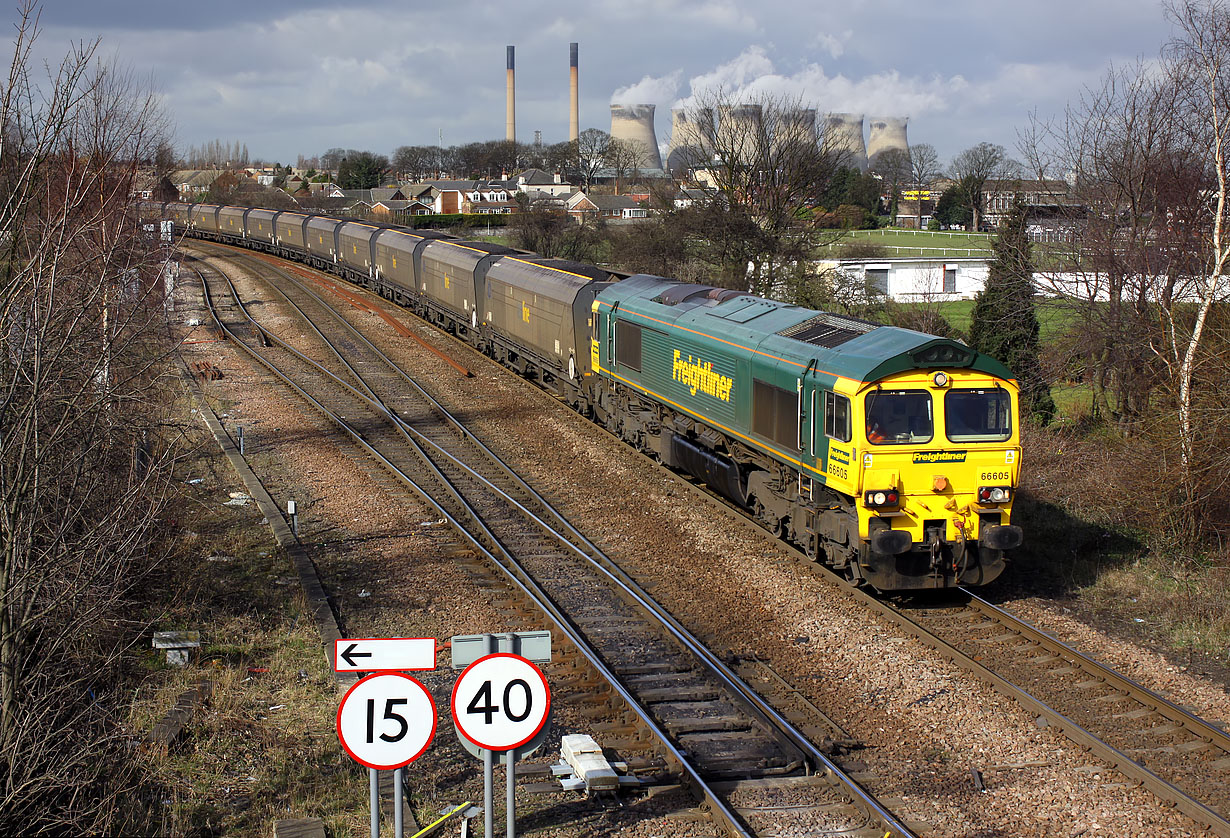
[590,276,1022,591]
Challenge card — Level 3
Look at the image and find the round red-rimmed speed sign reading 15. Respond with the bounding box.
[337,672,437,770]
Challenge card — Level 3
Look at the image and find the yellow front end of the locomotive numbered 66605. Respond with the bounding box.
[851,370,1022,588]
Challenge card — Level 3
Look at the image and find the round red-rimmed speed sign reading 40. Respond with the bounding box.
[453,652,551,751]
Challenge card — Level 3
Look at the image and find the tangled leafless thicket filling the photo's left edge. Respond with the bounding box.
[0,2,180,834]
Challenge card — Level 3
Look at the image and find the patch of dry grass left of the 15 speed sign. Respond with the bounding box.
[130,415,368,837]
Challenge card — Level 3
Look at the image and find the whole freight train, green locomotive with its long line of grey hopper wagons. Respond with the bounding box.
[143,203,1023,592]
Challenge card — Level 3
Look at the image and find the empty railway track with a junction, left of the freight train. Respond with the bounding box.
[189,251,914,838]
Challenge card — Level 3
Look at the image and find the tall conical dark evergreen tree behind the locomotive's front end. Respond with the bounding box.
[969,203,1055,425]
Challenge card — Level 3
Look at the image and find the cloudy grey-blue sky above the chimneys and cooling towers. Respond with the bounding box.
[19,0,1171,164]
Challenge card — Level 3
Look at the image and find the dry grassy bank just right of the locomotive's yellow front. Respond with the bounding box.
[1015,425,1230,667]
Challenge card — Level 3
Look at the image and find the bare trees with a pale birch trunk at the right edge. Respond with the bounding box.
[1027,0,1230,532]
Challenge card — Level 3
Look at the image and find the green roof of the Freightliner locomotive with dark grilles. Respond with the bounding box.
[599,274,1015,381]
